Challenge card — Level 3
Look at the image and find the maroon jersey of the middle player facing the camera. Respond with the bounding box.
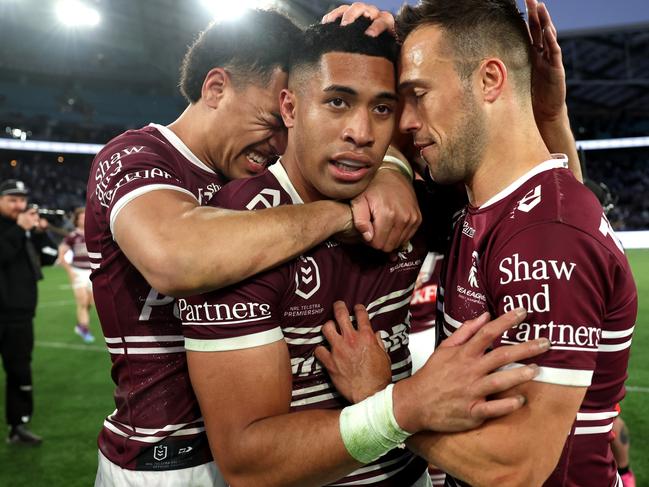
[178,163,426,487]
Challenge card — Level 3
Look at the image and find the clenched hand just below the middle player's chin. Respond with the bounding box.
[351,170,421,252]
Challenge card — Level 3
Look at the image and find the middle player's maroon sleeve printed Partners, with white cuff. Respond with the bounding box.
[178,266,287,352]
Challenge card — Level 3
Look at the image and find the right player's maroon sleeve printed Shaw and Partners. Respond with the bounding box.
[485,223,616,387]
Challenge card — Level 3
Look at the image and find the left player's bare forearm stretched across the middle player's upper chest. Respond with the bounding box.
[158,201,351,296]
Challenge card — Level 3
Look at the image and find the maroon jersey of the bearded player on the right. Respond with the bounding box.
[438,157,637,487]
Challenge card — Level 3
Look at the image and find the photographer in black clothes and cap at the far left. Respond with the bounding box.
[0,179,57,445]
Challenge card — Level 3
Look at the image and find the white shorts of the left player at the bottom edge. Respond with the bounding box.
[95,451,228,487]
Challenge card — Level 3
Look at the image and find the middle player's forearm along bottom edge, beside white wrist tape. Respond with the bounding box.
[208,410,361,487]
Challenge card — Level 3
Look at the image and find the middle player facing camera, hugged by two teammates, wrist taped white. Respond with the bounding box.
[178,20,547,487]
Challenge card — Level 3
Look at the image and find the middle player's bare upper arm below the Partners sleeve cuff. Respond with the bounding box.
[187,340,291,456]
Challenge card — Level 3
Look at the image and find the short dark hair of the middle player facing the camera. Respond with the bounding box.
[289,17,399,80]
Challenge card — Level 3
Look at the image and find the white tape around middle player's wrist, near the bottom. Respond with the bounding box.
[340,384,411,463]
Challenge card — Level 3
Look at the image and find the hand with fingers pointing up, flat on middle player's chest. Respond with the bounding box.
[315,301,392,403]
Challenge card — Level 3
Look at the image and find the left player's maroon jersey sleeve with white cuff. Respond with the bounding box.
[90,136,195,233]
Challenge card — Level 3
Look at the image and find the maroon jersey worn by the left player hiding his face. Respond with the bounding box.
[85,125,225,470]
